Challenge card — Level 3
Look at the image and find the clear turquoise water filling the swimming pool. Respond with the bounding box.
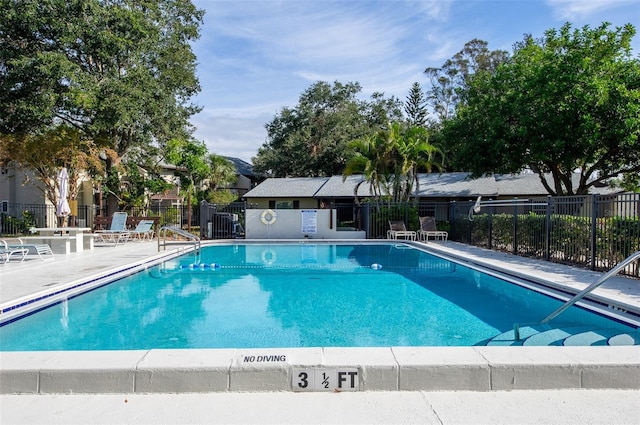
[0,243,630,351]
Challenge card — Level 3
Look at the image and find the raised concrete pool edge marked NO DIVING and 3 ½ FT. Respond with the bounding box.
[0,240,640,394]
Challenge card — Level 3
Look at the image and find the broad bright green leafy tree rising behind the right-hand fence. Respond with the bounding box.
[441,23,640,195]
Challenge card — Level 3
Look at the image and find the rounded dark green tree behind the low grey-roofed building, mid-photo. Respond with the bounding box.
[253,82,402,177]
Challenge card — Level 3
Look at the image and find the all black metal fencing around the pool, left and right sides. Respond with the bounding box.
[0,193,640,277]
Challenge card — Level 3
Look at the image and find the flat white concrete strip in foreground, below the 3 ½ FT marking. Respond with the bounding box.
[0,390,640,425]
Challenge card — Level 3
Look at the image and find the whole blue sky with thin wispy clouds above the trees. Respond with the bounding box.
[191,0,640,162]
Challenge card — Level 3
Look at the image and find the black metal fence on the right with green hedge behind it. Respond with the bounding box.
[357,193,640,277]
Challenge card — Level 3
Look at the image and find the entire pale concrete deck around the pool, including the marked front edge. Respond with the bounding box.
[0,241,640,424]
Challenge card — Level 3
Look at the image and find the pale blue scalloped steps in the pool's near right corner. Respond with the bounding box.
[486,325,640,346]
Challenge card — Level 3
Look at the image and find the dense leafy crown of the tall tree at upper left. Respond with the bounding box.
[0,0,202,162]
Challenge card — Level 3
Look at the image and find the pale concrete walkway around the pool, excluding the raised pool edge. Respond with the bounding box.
[0,242,640,425]
